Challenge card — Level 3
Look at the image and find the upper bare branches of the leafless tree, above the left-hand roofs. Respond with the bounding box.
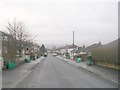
[6,19,30,41]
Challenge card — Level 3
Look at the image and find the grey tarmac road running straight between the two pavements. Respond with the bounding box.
[15,54,117,88]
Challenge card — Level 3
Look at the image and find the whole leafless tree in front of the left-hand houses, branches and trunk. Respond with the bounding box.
[6,19,36,56]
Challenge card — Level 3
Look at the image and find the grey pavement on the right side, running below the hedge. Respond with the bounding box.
[57,56,120,85]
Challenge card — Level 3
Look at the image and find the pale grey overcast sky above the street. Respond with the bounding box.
[0,0,119,47]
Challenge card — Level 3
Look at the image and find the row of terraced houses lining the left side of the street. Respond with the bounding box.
[0,31,44,69]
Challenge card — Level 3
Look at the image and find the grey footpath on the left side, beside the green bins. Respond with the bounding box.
[2,57,44,88]
